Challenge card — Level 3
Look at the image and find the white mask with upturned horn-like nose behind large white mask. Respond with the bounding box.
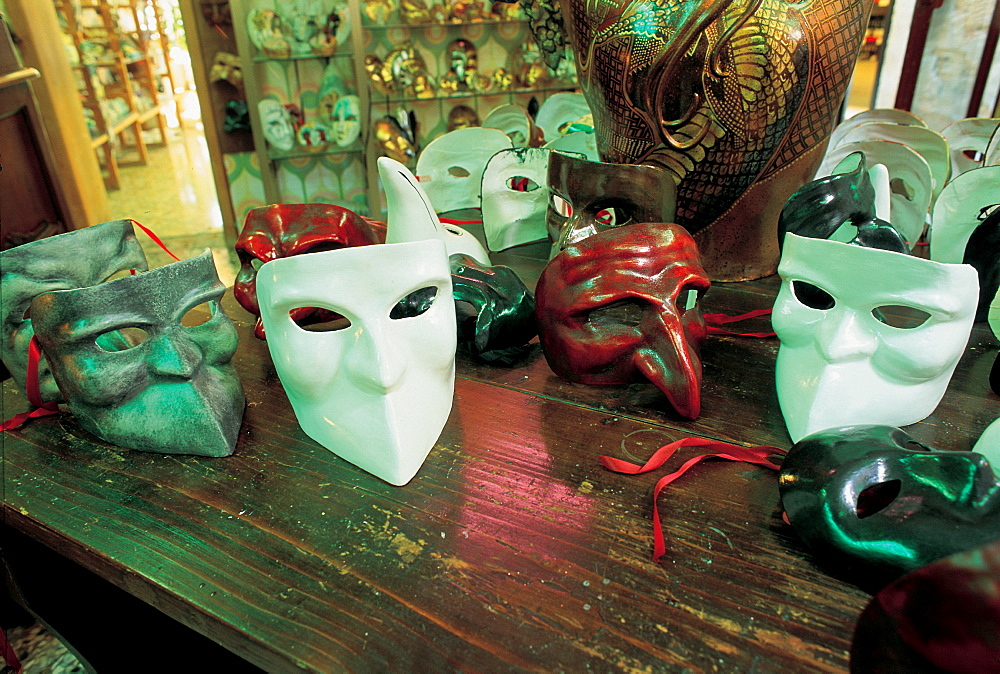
[378,156,493,267]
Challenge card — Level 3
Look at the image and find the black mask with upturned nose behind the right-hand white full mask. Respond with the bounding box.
[778,152,910,254]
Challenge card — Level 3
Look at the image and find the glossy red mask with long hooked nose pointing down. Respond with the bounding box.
[535,223,709,419]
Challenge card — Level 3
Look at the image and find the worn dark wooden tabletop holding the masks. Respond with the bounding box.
[3,248,998,672]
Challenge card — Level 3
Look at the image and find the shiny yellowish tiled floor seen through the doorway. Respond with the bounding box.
[108,96,238,286]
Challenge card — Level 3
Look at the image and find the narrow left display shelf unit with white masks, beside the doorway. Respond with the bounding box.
[230,0,370,214]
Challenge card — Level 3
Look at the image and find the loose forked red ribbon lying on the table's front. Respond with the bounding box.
[600,438,785,562]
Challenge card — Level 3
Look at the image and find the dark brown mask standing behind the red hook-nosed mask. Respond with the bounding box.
[547,152,677,255]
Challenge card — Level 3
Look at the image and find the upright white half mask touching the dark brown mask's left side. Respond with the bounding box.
[482,147,550,251]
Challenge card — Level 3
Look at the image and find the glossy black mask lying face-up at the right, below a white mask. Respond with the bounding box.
[780,425,1000,582]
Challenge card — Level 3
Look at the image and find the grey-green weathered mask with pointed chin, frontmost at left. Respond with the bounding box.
[31,251,245,456]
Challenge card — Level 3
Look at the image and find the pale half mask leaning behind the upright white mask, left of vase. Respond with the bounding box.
[417,127,511,213]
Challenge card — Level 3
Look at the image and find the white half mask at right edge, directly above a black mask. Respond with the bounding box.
[931,166,1000,262]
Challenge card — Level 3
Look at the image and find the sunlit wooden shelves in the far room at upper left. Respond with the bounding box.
[55,0,174,189]
